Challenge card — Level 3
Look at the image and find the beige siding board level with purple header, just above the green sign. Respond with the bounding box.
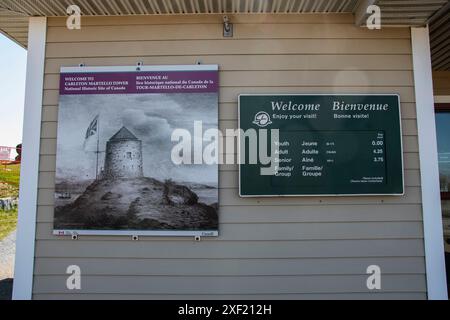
[44,70,413,90]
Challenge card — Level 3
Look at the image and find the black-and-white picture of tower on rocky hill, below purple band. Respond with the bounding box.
[55,90,219,234]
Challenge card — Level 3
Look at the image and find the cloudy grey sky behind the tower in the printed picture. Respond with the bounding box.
[56,93,218,185]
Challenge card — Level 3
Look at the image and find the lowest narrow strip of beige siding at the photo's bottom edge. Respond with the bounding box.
[33,291,427,300]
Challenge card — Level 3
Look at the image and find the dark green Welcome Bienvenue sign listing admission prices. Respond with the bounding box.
[239,95,404,197]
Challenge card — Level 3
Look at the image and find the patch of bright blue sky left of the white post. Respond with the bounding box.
[0,34,27,147]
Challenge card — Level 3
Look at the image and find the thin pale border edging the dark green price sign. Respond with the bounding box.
[238,93,406,198]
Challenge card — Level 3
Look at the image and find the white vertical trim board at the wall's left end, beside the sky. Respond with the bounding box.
[13,17,47,300]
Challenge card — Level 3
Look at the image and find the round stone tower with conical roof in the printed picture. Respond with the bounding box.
[104,127,144,179]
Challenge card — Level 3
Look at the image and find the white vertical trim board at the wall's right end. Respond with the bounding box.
[411,27,447,300]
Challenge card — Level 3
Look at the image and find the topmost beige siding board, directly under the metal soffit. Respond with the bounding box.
[48,14,354,27]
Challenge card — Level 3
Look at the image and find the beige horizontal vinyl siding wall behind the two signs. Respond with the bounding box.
[33,15,426,299]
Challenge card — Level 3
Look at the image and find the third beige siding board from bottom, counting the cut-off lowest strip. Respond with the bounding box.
[35,257,425,276]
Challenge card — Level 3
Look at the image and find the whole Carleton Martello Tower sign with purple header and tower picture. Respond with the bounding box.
[54,65,219,236]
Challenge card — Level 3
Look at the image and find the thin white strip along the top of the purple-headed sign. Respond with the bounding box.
[61,64,219,73]
